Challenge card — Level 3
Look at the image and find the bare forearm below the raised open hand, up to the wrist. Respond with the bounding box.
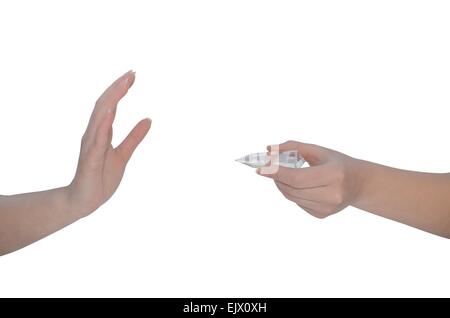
[0,187,82,255]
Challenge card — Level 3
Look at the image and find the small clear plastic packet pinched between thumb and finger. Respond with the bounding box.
[236,150,305,168]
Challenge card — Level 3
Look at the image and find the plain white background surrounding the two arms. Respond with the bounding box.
[0,0,450,297]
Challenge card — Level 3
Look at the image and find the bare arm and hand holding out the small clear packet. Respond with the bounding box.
[257,141,450,238]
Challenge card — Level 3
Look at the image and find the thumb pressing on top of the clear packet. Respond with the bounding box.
[267,140,329,166]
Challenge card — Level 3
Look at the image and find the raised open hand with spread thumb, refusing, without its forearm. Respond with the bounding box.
[68,71,151,216]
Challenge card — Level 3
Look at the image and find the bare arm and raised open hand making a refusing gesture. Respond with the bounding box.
[0,71,151,255]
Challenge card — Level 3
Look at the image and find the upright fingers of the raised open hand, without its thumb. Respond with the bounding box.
[85,71,135,140]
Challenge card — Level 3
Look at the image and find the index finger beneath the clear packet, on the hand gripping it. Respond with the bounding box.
[256,166,330,189]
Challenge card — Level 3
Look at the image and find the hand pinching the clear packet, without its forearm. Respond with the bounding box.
[257,141,364,218]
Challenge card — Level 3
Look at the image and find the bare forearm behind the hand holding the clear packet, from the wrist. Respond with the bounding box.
[353,161,450,238]
